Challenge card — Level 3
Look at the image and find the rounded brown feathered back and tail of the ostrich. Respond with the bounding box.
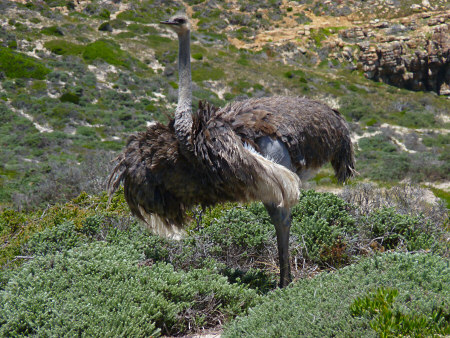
[219,96,355,181]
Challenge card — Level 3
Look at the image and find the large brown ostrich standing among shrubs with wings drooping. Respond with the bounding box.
[108,15,355,287]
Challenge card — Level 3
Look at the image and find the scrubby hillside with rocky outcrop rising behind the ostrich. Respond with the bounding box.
[0,0,450,208]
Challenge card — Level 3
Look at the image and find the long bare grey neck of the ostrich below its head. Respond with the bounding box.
[175,31,192,149]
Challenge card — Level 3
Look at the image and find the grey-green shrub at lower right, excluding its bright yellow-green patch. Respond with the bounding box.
[223,253,450,337]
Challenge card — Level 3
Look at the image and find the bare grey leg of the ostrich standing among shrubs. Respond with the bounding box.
[264,204,292,288]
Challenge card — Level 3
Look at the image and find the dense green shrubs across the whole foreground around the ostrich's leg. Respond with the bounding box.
[0,186,450,336]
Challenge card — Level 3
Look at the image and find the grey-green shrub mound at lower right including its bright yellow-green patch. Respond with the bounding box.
[224,253,450,337]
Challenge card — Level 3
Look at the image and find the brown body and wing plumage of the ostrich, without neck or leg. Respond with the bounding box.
[108,97,354,236]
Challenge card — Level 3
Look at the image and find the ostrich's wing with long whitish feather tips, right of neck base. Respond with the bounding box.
[191,103,299,207]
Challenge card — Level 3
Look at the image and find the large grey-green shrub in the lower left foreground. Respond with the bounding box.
[0,242,259,337]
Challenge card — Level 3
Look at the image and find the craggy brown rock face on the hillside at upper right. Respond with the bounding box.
[356,19,450,95]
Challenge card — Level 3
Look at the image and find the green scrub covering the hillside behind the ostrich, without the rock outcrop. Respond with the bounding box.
[0,0,450,208]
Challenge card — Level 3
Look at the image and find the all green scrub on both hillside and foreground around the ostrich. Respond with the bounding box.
[0,0,450,337]
